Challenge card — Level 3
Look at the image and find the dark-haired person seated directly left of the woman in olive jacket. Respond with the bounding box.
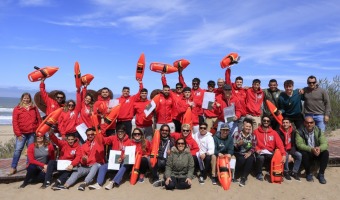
[151,124,174,187]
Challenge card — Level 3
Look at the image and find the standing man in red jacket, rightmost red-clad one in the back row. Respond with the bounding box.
[246,79,264,130]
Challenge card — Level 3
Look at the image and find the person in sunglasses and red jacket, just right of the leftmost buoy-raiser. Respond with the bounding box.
[58,97,84,140]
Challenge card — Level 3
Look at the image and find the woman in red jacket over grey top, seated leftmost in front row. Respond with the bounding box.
[19,134,55,188]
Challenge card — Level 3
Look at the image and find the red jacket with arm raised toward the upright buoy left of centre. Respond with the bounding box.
[117,83,143,121]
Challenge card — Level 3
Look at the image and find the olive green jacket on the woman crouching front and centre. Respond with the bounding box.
[164,146,195,179]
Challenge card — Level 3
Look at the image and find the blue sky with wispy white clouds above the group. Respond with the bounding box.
[0,0,340,96]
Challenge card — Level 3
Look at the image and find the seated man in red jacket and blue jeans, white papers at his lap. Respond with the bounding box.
[89,124,131,190]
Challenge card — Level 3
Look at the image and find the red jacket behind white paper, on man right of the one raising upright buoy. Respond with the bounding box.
[133,99,153,128]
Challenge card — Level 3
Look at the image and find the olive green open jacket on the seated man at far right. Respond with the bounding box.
[295,126,328,152]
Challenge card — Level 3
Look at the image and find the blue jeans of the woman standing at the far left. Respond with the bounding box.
[11,133,35,169]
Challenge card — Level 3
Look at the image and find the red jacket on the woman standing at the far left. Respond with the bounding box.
[12,106,42,137]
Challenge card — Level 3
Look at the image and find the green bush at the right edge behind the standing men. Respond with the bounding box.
[319,76,340,133]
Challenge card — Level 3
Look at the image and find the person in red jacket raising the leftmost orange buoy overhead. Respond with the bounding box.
[40,78,66,116]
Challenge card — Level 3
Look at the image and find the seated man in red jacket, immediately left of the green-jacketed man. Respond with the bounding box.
[277,118,302,181]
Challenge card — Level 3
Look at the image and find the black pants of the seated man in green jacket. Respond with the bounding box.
[301,150,329,174]
